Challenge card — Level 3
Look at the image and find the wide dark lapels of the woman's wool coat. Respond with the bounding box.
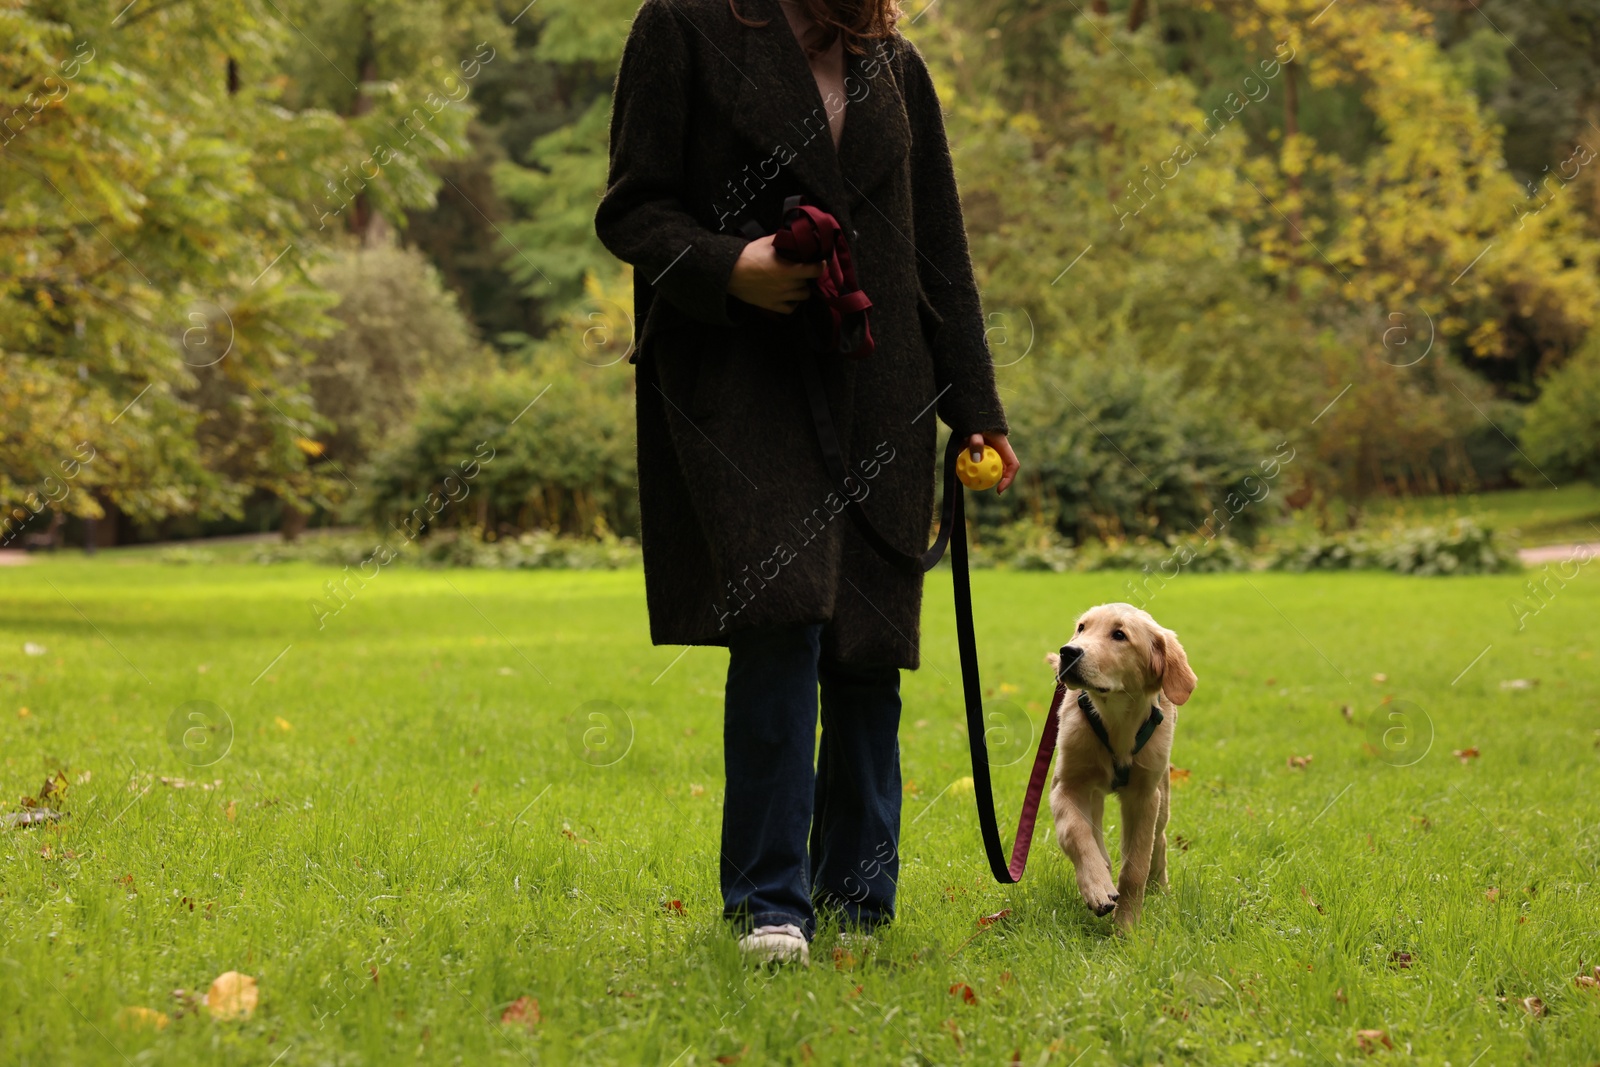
[733,0,910,229]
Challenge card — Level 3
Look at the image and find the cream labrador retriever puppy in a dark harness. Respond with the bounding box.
[1045,603,1197,931]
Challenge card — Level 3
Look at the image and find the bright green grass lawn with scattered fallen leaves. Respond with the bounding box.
[0,553,1600,1067]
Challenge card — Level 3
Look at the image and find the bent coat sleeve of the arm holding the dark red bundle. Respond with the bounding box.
[595,0,746,326]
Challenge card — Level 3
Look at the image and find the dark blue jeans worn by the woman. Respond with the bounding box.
[722,624,901,939]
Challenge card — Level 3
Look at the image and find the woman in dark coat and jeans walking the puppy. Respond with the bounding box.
[595,0,1018,960]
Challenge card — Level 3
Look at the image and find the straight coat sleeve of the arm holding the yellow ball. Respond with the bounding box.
[898,40,1010,434]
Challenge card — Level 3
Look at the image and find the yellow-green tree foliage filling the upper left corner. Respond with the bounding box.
[0,0,505,531]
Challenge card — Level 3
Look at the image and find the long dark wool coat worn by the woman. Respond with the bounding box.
[595,0,1006,667]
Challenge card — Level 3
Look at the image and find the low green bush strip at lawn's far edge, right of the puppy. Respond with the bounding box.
[1270,518,1522,576]
